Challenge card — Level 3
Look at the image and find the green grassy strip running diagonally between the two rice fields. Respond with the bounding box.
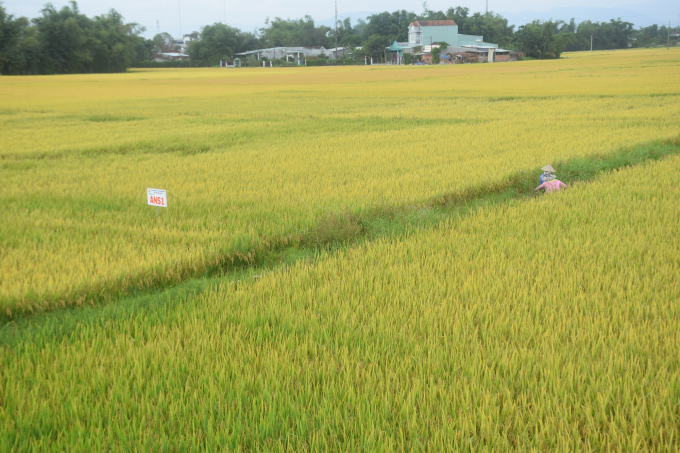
[0,136,680,323]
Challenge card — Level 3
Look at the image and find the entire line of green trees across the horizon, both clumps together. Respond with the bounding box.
[0,1,677,74]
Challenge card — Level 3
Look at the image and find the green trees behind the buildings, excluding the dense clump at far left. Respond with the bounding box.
[189,3,676,65]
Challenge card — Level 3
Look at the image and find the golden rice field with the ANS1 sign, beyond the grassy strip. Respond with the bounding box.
[0,49,680,319]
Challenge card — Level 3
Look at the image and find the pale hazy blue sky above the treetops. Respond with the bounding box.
[0,0,680,38]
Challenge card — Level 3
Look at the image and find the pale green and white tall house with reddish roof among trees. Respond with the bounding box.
[408,20,498,48]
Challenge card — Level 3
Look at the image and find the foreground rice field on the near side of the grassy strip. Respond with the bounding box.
[0,156,680,451]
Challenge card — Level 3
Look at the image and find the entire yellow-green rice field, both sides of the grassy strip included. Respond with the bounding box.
[0,49,680,446]
